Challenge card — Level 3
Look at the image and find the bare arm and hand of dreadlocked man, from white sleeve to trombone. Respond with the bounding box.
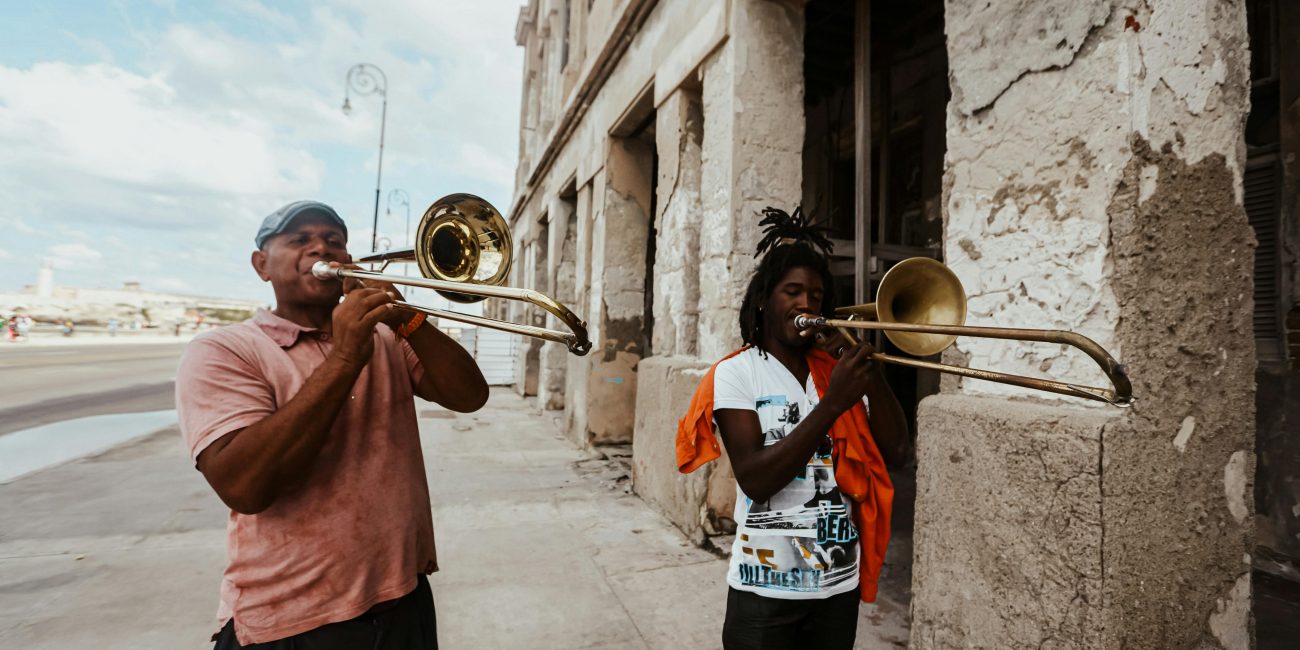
[714,346,870,501]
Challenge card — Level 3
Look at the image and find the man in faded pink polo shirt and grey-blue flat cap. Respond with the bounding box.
[176,202,488,649]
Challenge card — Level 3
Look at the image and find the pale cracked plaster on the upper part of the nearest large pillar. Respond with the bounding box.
[944,1,1245,405]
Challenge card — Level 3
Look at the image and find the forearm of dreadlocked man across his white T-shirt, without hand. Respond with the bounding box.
[731,406,842,501]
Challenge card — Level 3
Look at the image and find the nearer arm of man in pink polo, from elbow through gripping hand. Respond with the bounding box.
[198,289,393,515]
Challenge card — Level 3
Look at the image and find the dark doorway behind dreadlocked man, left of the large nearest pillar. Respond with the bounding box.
[802,0,949,637]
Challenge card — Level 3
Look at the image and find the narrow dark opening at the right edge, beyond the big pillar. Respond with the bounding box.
[1242,0,1300,649]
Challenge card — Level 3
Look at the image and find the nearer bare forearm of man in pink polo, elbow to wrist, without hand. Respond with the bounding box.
[200,358,360,514]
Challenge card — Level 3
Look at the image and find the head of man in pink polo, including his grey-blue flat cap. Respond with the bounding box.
[252,213,352,306]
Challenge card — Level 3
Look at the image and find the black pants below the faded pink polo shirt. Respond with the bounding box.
[213,575,438,650]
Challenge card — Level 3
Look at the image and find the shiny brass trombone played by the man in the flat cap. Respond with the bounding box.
[312,194,592,356]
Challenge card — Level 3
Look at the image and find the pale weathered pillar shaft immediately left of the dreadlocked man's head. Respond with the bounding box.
[698,0,803,360]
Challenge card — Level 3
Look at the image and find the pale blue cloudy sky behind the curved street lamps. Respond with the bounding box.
[0,0,524,302]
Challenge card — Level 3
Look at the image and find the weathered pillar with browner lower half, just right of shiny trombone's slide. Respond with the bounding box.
[586,138,654,443]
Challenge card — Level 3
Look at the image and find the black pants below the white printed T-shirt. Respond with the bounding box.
[723,588,858,650]
